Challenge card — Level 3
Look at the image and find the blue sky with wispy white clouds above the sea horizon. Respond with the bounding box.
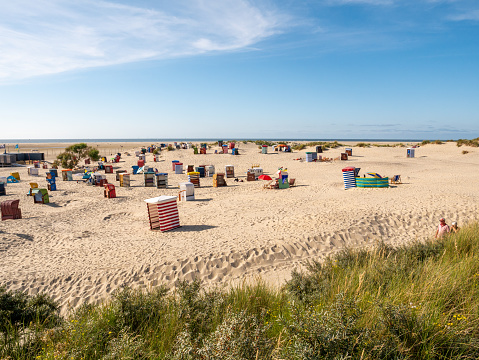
[0,0,479,140]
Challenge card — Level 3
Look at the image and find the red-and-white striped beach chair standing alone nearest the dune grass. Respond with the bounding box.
[145,195,180,231]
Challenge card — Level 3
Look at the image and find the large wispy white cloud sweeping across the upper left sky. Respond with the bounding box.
[0,0,288,81]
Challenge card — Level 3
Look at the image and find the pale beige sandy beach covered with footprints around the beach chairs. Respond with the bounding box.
[0,143,479,313]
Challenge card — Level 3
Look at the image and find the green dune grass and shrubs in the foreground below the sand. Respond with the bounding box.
[0,223,479,359]
